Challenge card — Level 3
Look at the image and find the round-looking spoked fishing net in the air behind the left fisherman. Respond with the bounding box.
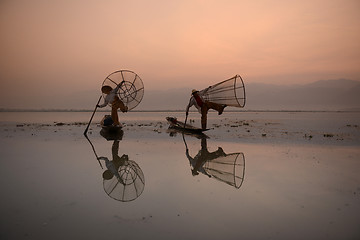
[102,70,144,110]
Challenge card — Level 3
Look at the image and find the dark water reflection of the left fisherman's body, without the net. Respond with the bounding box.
[98,140,129,182]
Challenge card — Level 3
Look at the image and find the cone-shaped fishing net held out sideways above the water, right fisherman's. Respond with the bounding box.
[201,75,245,108]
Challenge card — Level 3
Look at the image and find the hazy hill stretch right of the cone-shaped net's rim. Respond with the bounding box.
[246,79,360,110]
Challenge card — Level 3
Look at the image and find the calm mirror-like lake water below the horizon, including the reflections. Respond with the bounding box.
[0,113,360,239]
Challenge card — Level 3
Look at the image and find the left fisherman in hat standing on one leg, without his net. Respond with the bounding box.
[97,83,128,126]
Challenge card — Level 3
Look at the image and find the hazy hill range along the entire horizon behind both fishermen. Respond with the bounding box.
[3,79,360,111]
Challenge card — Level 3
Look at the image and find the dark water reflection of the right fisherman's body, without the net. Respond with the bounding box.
[186,137,226,177]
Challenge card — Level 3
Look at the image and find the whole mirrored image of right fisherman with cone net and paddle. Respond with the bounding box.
[183,134,245,188]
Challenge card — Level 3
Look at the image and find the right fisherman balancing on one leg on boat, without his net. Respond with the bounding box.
[186,88,226,130]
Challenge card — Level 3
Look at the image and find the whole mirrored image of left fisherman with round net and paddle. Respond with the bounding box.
[85,132,145,202]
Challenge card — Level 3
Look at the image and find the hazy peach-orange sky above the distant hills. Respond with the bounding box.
[0,0,360,107]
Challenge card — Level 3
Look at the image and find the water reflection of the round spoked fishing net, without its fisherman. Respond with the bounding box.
[103,160,145,202]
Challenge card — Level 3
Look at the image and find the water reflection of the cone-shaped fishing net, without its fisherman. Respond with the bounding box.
[204,153,245,188]
